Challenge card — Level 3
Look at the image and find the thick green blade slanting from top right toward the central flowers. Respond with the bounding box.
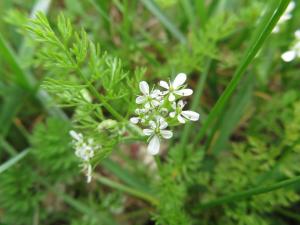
[194,0,290,144]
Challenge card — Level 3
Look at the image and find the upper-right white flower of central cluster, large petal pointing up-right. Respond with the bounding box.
[159,73,193,102]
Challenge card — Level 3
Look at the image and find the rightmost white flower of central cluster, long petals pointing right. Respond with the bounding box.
[169,100,200,123]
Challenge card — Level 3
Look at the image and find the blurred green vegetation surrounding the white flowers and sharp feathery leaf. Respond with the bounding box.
[0,0,300,225]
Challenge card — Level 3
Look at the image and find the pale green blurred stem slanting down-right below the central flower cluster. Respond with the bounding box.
[94,174,159,205]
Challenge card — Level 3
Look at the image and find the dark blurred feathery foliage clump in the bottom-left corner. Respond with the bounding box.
[0,160,45,225]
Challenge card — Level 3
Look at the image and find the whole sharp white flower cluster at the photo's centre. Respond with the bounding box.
[130,73,199,155]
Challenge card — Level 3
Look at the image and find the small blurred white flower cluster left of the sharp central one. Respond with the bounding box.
[70,130,101,183]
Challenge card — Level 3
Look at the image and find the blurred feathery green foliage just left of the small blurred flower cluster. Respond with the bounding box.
[31,118,78,184]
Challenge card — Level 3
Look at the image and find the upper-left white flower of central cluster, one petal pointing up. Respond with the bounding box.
[135,81,161,109]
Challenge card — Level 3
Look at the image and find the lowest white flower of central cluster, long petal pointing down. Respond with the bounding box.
[143,117,173,155]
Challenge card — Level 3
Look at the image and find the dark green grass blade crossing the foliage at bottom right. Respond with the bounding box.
[199,176,300,209]
